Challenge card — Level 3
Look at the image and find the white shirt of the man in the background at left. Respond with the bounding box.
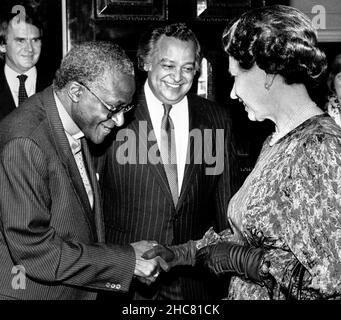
[5,64,37,107]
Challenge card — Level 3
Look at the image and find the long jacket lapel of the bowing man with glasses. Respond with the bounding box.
[42,87,99,239]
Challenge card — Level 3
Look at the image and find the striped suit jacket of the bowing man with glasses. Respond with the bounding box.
[0,87,135,300]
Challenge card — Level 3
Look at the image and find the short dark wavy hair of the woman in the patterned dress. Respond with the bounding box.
[223,5,327,88]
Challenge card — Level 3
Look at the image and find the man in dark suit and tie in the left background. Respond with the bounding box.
[0,8,49,119]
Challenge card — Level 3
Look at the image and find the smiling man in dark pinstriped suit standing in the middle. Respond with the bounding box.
[100,23,232,300]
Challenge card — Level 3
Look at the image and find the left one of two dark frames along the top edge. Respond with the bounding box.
[95,0,168,21]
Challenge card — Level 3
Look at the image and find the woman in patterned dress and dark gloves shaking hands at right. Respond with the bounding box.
[145,5,341,300]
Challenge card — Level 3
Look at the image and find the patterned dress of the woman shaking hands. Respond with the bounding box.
[225,114,341,300]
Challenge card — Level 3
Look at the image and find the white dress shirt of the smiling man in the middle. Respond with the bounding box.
[144,81,189,195]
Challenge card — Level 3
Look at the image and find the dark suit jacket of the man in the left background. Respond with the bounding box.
[0,64,50,120]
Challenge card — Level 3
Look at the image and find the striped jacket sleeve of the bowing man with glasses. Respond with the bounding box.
[0,138,135,291]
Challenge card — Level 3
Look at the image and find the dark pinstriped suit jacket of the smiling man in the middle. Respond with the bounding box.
[99,93,232,299]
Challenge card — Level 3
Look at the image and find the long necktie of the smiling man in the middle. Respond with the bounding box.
[160,104,178,207]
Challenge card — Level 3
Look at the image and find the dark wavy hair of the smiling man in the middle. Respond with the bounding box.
[137,23,202,71]
